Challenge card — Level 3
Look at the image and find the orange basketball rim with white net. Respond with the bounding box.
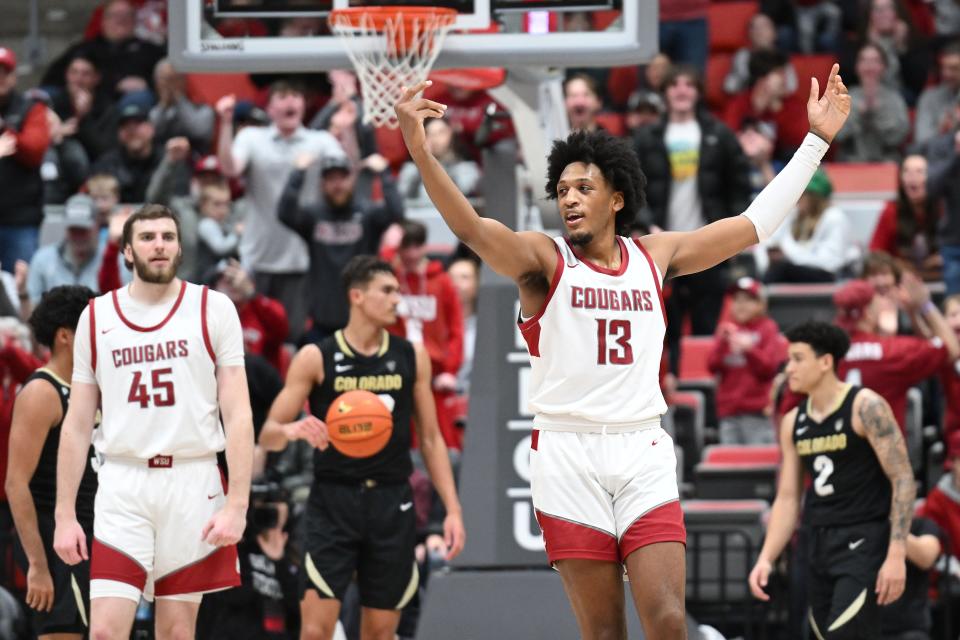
[329,7,457,129]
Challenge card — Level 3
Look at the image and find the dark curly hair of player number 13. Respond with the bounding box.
[546,131,647,235]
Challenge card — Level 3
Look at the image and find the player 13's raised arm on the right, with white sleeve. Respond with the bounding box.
[642,64,850,277]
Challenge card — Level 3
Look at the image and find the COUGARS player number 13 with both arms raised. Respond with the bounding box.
[396,65,850,640]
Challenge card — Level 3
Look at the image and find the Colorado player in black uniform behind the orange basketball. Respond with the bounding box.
[260,256,465,640]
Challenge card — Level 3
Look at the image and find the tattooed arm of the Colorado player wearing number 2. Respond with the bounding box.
[853,389,917,605]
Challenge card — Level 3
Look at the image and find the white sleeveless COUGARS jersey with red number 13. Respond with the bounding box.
[519,236,667,431]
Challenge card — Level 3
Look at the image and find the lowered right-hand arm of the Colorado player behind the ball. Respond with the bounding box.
[413,344,467,560]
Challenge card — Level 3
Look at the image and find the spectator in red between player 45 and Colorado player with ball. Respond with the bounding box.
[204,258,290,375]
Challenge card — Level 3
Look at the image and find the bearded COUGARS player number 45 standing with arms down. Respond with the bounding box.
[54,205,253,639]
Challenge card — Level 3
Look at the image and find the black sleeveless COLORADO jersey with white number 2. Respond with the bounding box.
[793,386,891,527]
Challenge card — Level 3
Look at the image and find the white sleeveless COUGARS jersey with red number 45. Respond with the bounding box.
[89,282,225,459]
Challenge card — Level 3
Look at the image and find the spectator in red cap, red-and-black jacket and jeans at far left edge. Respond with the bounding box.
[0,46,50,269]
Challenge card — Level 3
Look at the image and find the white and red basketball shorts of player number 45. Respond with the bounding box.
[90,456,240,602]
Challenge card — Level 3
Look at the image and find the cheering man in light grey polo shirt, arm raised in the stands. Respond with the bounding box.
[216,81,346,340]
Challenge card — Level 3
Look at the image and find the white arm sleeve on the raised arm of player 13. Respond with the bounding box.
[742,133,830,242]
